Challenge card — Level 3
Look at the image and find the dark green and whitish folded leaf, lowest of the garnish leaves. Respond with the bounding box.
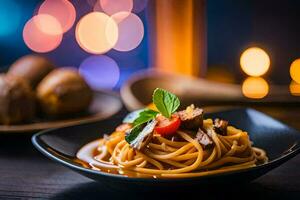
[125,119,157,149]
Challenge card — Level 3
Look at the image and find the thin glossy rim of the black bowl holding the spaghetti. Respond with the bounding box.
[31,108,300,182]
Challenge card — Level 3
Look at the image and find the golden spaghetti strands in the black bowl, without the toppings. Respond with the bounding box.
[78,119,268,178]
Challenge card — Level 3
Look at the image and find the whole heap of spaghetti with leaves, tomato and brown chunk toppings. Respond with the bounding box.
[77,88,268,178]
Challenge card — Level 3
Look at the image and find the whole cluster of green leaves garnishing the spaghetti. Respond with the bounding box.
[123,88,180,149]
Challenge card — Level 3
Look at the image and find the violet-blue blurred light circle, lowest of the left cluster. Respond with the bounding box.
[79,55,120,90]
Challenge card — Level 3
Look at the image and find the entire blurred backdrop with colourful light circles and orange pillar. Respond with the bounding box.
[0,0,300,95]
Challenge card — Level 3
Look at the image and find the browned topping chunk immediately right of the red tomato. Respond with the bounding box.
[177,104,203,130]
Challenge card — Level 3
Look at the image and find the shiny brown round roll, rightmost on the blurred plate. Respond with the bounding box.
[37,68,93,116]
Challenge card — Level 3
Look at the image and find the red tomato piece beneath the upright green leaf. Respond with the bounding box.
[154,115,181,136]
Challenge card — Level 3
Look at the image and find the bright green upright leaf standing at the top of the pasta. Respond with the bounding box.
[152,88,180,118]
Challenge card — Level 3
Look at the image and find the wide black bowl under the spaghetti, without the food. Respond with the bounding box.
[32,109,300,190]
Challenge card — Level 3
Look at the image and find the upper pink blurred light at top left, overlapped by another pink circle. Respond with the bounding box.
[38,0,76,33]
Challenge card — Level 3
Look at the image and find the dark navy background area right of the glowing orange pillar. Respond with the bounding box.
[207,0,300,84]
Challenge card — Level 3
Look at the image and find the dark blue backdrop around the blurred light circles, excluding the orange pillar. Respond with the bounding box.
[0,0,300,87]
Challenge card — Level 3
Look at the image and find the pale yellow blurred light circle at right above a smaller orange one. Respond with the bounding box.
[240,47,270,76]
